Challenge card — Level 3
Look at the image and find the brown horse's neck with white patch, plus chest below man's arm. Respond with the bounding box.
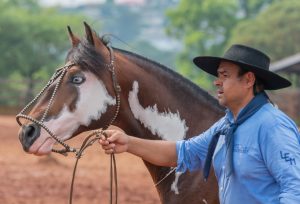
[112,51,223,203]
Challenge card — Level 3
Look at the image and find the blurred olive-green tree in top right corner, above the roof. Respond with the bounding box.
[228,0,300,61]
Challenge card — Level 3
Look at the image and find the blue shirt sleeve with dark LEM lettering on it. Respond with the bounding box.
[260,118,300,204]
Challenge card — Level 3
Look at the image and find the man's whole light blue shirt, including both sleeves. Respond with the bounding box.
[176,103,300,204]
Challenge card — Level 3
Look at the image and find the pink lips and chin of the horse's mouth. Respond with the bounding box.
[28,137,55,156]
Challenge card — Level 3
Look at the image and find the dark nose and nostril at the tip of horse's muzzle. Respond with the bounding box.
[19,123,41,152]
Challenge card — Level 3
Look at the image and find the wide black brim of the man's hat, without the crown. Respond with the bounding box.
[193,56,291,90]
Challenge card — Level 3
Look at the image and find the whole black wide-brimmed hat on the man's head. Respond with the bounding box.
[193,45,291,90]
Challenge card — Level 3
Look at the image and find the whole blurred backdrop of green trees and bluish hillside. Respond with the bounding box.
[0,0,300,122]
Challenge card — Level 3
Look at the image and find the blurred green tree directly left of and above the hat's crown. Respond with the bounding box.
[167,0,278,89]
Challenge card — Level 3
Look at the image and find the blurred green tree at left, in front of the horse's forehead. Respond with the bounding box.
[0,0,83,103]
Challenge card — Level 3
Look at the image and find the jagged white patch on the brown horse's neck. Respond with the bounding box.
[128,81,188,141]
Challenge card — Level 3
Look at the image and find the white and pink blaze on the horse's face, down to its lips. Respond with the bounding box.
[29,72,116,154]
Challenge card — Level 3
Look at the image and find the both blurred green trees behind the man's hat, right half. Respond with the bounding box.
[167,0,300,89]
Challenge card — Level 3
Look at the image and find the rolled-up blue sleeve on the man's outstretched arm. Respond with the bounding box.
[176,118,224,172]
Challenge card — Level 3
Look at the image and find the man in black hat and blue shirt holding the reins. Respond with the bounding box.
[99,45,300,204]
